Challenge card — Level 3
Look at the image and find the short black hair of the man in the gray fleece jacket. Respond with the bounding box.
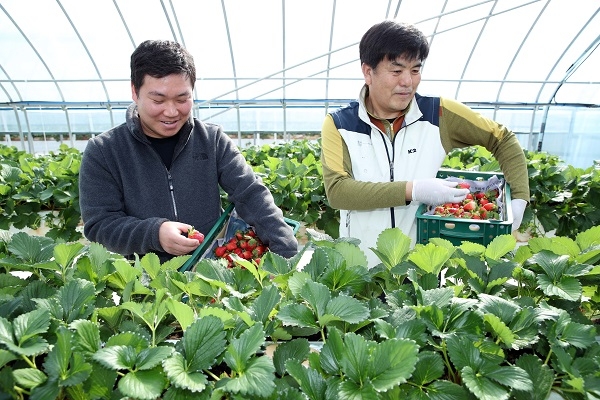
[130,40,196,94]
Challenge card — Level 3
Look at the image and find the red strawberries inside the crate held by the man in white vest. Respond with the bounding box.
[433,182,500,220]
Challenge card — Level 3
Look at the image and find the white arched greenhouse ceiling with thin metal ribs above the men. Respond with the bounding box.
[0,0,600,109]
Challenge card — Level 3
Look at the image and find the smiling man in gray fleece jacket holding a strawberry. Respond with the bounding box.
[79,40,298,262]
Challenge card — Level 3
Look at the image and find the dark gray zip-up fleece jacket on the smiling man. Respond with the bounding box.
[79,104,298,262]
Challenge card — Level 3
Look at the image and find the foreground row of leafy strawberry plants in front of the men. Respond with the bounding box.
[0,227,600,400]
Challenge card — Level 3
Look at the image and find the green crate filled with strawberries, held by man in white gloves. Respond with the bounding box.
[417,169,512,245]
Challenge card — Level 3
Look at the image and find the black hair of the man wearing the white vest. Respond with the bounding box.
[358,20,429,68]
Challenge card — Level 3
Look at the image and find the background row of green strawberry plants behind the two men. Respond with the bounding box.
[0,140,600,241]
